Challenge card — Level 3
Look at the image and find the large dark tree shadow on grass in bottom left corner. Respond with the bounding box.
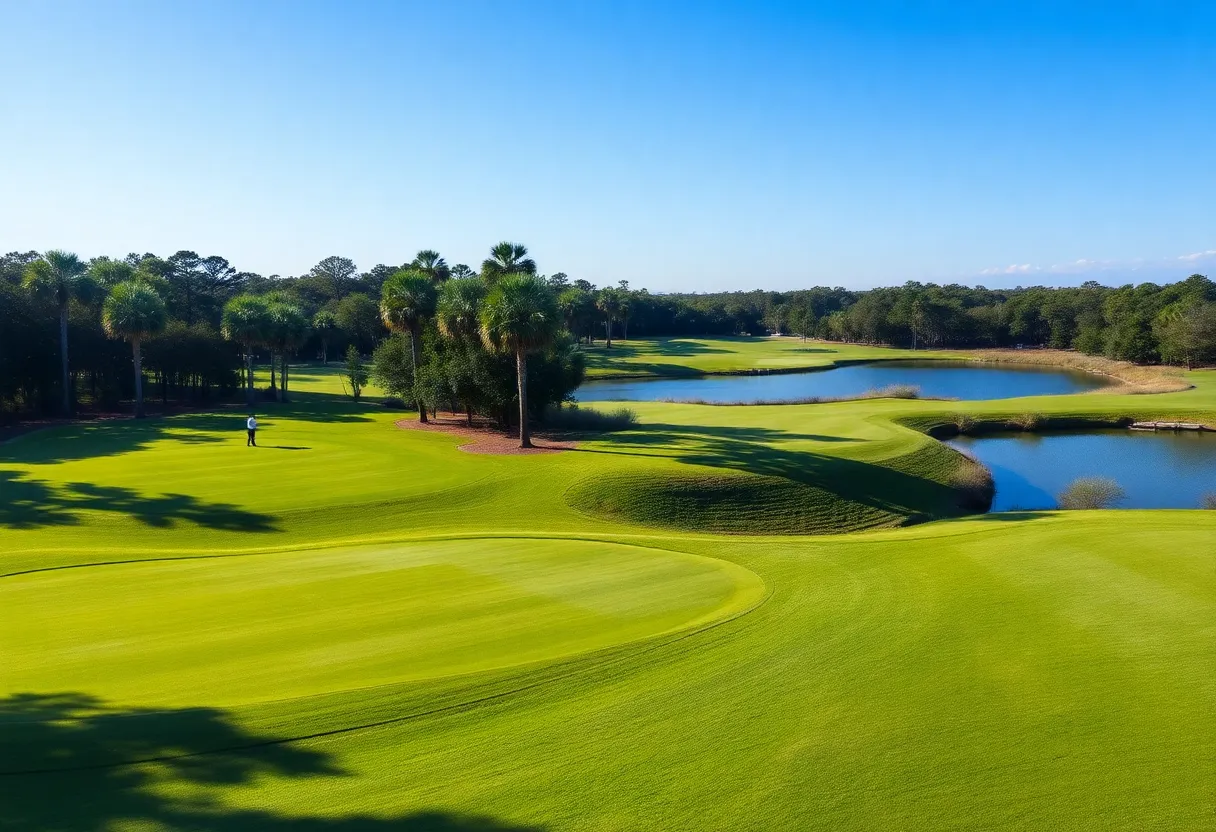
[0,693,541,832]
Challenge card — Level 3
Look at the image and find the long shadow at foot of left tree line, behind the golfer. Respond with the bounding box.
[0,403,372,465]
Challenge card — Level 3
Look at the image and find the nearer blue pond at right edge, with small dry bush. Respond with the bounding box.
[947,431,1216,511]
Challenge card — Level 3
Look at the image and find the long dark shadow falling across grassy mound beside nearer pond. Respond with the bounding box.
[576,423,959,519]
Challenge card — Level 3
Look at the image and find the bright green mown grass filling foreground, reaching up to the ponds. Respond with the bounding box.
[0,335,1216,832]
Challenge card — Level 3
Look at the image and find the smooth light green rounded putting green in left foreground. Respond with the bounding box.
[0,539,764,705]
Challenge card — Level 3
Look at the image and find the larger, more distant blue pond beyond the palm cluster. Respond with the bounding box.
[575,361,1110,401]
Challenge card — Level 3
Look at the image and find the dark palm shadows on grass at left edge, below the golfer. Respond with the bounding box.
[0,471,276,532]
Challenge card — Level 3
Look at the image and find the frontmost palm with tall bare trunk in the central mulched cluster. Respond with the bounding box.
[480,274,562,448]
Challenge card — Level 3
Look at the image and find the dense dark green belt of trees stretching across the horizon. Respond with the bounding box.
[0,243,1216,421]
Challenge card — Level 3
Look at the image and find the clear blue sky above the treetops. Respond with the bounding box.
[0,0,1216,291]
